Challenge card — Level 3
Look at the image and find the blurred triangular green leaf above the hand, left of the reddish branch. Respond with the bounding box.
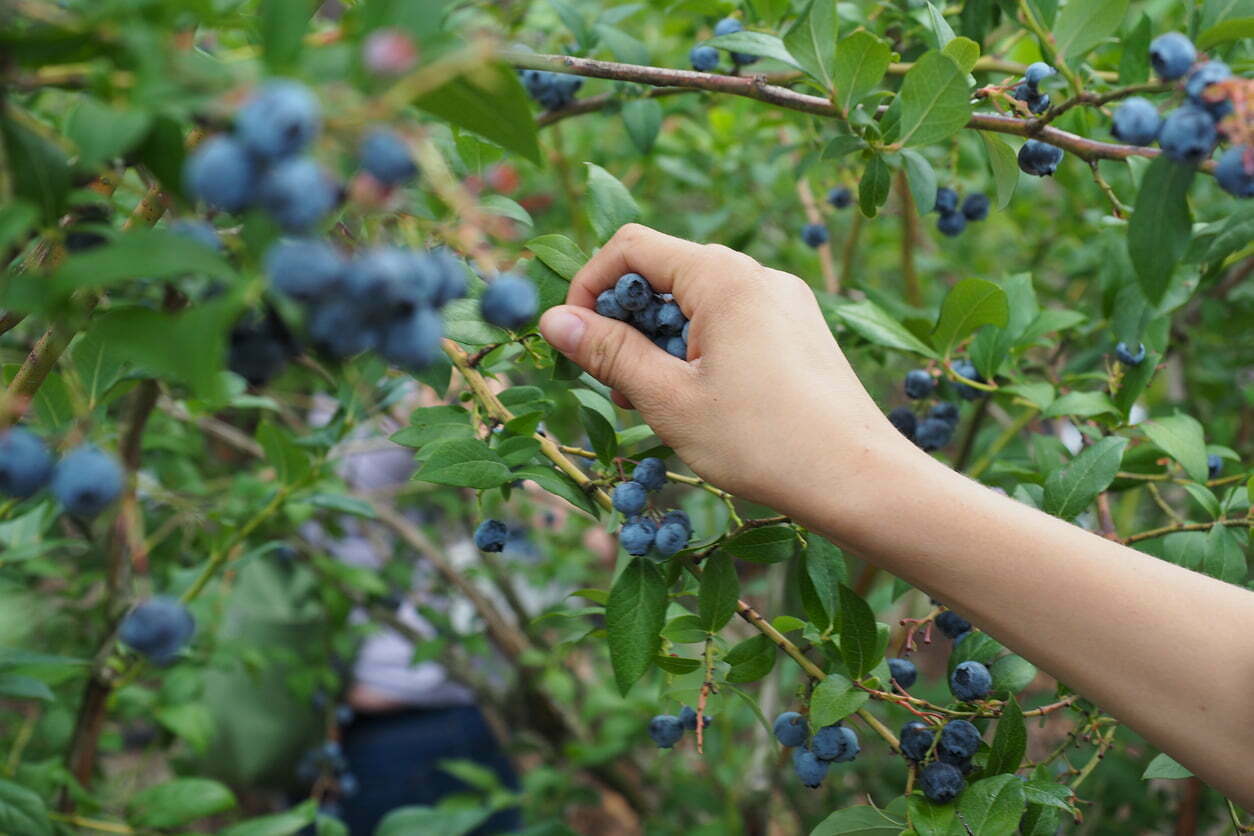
[414,63,543,165]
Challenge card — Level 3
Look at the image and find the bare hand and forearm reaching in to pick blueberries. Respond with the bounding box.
[540,224,1254,808]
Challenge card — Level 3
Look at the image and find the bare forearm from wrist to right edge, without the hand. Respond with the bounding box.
[796,444,1254,806]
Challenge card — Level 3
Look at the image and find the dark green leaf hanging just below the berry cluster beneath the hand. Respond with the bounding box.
[606,558,666,696]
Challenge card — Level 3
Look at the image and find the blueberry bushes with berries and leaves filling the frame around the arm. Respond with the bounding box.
[0,0,1254,836]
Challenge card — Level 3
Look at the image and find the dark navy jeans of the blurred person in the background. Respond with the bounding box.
[342,706,523,836]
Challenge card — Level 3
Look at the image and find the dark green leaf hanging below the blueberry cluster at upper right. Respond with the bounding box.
[1128,155,1196,305]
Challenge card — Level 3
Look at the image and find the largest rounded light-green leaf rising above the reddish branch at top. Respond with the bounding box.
[898,51,971,147]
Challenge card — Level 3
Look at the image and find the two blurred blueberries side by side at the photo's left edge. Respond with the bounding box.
[0,427,123,518]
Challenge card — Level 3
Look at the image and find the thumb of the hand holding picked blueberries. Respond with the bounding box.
[540,305,692,406]
